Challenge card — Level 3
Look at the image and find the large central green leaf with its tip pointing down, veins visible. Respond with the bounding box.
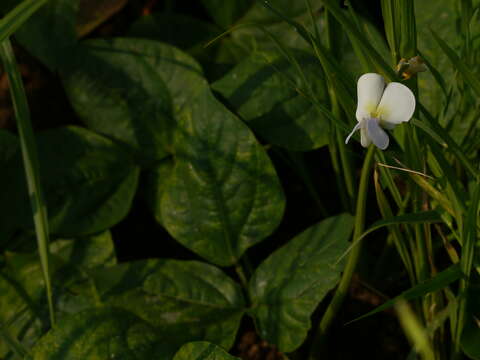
[161,84,284,266]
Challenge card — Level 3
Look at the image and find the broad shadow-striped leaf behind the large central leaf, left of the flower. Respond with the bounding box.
[212,51,330,151]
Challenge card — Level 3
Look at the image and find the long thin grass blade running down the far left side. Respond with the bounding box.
[0,39,55,326]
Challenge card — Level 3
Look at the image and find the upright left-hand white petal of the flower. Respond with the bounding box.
[355,73,385,121]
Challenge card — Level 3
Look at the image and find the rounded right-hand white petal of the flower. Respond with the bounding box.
[377,82,415,128]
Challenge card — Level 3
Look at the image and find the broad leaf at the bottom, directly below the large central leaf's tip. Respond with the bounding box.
[94,260,245,348]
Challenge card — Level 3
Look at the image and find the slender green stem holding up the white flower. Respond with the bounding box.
[310,145,375,358]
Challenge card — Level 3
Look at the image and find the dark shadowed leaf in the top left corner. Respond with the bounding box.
[0,0,78,71]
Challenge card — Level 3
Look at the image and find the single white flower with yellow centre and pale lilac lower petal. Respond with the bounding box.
[345,73,415,150]
